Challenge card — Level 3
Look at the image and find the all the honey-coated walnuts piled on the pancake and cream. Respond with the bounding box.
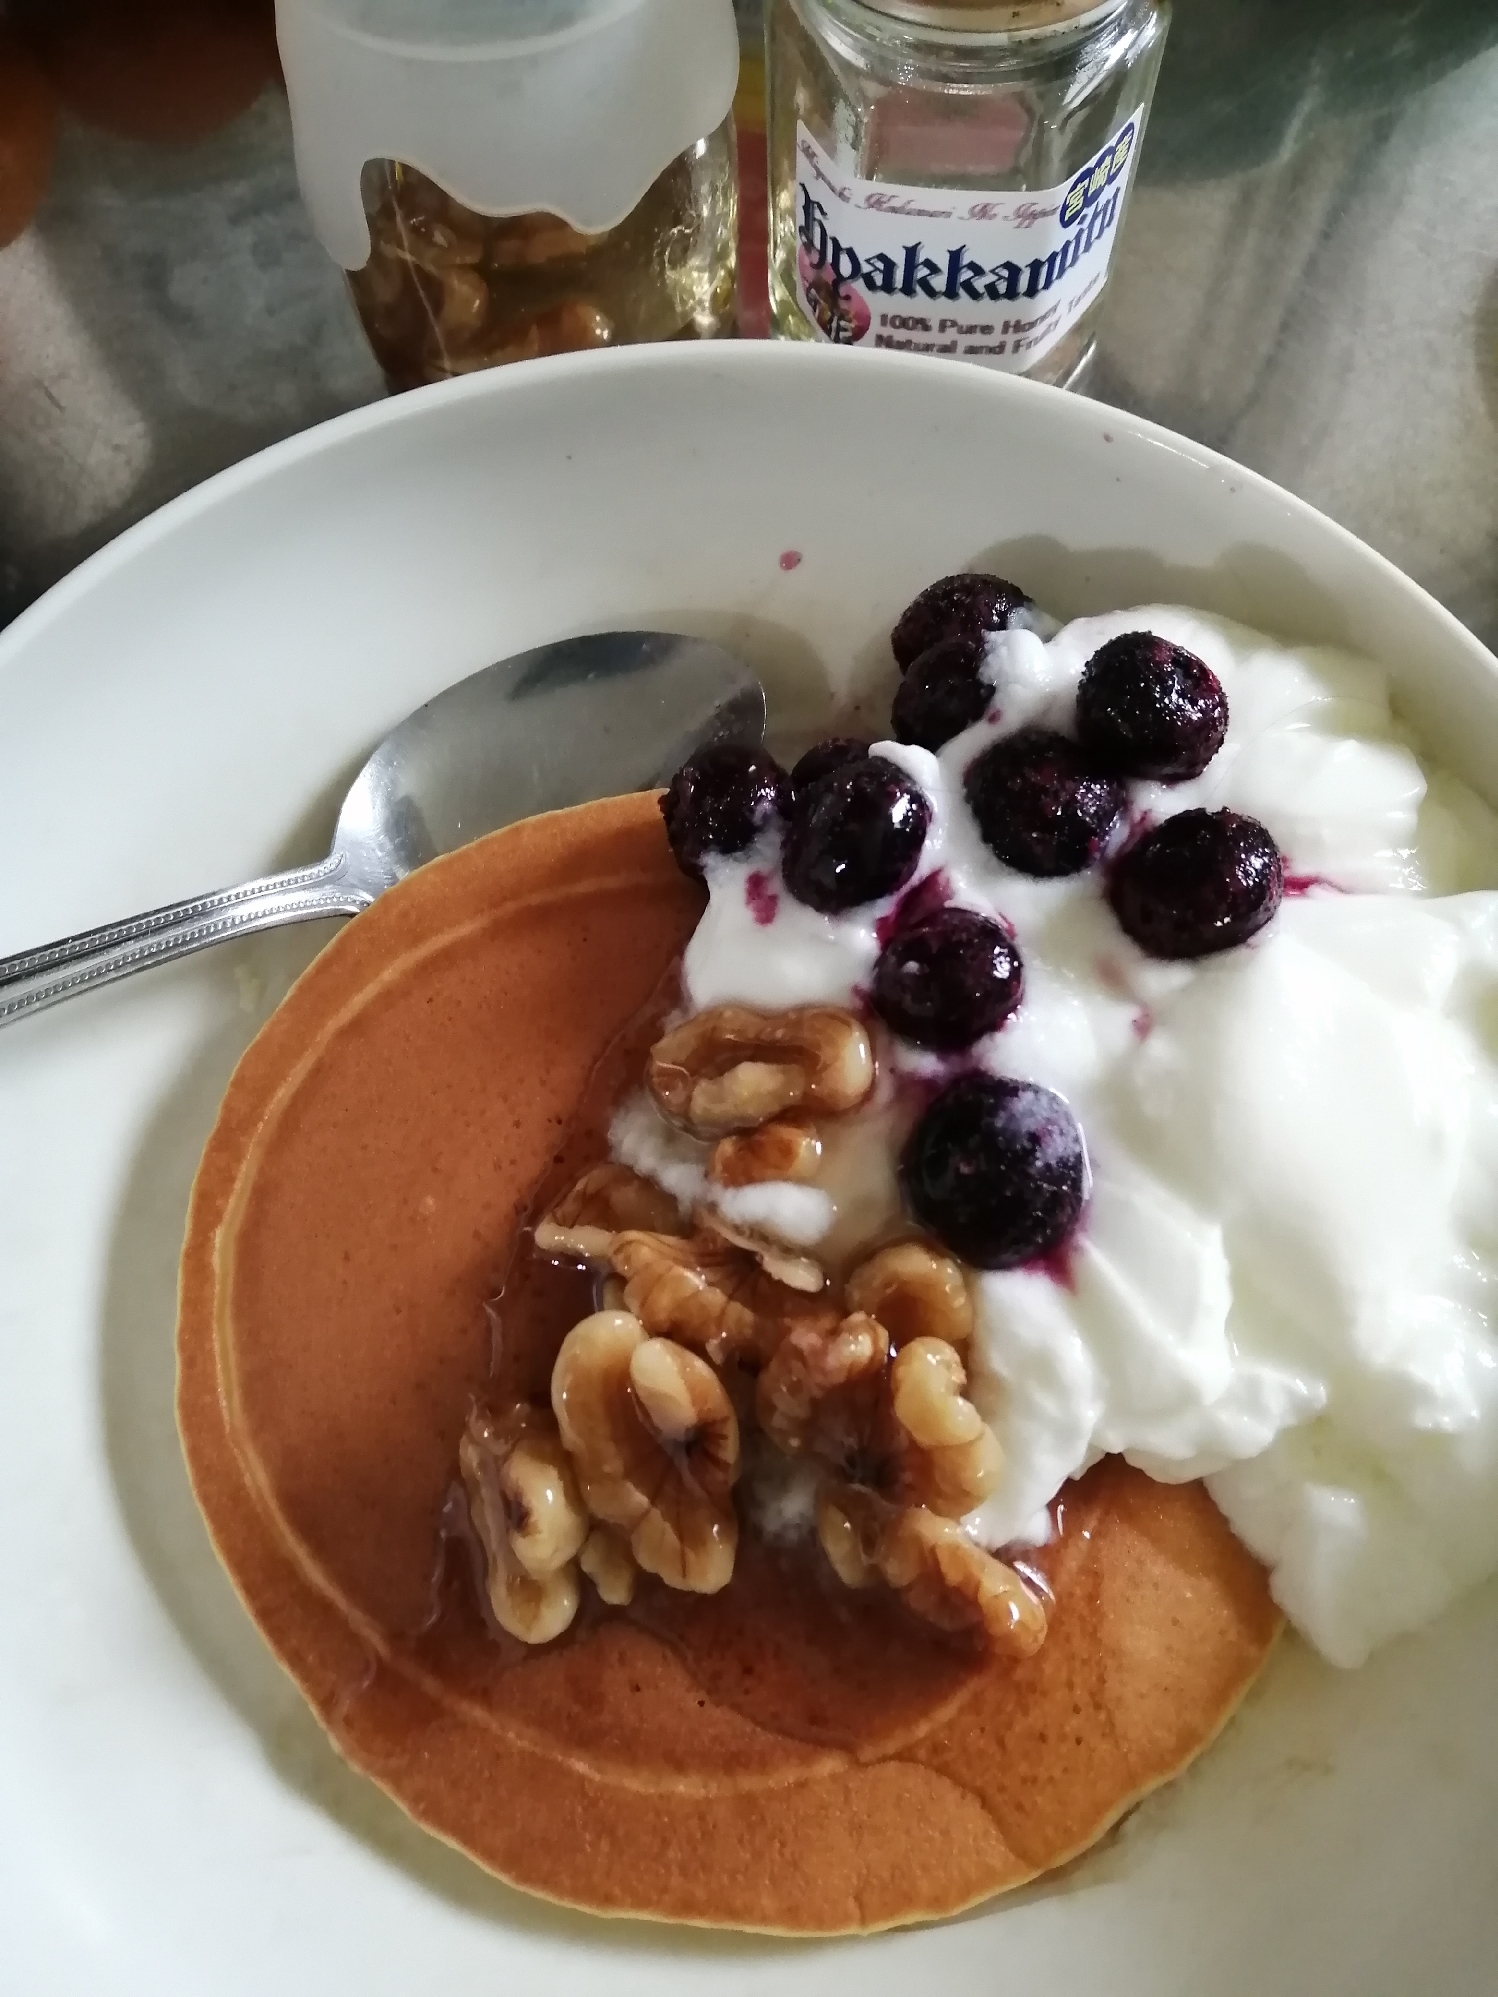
[459,1006,1045,1656]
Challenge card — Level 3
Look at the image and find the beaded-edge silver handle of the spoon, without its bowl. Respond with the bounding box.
[0,853,374,1026]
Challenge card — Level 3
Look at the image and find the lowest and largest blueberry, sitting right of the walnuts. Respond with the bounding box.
[901,1074,1087,1268]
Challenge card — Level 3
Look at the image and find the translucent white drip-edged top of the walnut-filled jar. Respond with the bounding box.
[276,0,739,270]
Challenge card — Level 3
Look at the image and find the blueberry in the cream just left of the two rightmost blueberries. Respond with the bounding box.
[963,729,1124,875]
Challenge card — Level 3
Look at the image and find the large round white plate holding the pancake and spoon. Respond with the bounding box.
[0,345,1498,1997]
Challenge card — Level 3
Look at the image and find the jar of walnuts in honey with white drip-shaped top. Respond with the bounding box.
[276,0,739,387]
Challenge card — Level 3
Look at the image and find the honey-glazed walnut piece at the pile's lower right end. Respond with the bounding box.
[817,1484,1047,1658]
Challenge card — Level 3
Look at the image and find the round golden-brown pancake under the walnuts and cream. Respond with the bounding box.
[178,797,1278,1933]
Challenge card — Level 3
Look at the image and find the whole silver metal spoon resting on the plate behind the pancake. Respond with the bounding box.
[0,631,765,1026]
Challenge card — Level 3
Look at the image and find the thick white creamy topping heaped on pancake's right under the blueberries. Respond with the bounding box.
[615,607,1498,1665]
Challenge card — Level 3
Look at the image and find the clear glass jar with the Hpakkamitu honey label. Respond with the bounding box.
[765,0,1168,385]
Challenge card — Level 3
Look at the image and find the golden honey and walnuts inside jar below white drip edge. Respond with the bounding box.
[350,122,737,389]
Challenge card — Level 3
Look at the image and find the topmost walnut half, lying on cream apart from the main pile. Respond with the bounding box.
[645,1004,875,1136]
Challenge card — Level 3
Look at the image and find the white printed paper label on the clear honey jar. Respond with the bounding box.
[797,108,1144,373]
